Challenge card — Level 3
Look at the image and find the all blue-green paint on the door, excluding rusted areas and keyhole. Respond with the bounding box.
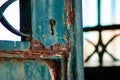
[0,0,84,80]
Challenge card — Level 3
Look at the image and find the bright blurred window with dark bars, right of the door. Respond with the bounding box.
[83,0,120,66]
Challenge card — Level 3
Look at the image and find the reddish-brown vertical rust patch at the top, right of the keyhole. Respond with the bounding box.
[65,0,75,26]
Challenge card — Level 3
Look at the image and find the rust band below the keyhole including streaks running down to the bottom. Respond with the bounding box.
[0,35,70,80]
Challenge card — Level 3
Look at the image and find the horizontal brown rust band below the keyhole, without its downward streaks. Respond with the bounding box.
[0,36,70,59]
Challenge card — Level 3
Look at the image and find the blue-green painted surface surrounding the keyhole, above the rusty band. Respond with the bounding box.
[31,0,66,47]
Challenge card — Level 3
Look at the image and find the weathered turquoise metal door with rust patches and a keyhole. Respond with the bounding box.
[0,0,84,80]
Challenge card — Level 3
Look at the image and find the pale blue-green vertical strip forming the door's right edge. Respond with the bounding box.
[74,0,84,80]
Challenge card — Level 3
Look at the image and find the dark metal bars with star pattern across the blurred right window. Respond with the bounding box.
[83,0,120,66]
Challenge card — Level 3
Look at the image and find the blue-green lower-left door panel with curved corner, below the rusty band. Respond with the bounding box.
[0,59,51,80]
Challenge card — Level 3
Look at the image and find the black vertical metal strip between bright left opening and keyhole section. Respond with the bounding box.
[19,0,32,41]
